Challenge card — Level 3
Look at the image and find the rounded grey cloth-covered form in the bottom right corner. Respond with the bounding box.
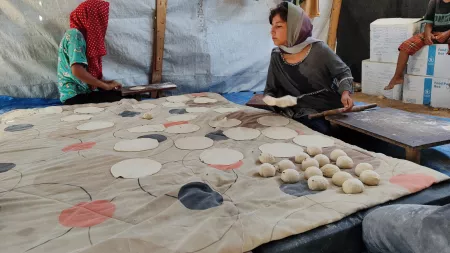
[362,205,450,253]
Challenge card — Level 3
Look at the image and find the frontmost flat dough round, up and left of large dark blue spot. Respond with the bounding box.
[111,158,162,178]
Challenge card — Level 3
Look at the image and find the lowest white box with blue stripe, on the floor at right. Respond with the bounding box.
[403,75,450,108]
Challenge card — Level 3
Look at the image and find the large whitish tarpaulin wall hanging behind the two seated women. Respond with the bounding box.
[0,0,331,98]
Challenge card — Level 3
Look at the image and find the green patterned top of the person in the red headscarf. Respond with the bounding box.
[58,29,91,103]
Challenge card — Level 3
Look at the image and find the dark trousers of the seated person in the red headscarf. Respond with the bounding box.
[64,90,122,105]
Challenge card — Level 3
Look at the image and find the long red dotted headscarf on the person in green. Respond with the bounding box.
[70,0,109,79]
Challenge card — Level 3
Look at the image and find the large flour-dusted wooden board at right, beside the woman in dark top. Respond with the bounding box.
[326,108,450,149]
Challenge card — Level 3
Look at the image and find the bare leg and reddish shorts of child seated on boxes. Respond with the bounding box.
[384,33,425,90]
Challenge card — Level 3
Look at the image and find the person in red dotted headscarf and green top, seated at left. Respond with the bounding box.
[58,0,122,105]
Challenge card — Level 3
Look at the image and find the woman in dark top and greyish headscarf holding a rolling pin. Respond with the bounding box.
[264,2,353,135]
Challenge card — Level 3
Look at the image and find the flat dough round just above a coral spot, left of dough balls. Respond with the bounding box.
[200,148,244,165]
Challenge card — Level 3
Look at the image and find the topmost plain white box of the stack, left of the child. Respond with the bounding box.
[370,18,424,63]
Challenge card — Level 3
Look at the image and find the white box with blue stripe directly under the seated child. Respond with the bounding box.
[407,44,450,78]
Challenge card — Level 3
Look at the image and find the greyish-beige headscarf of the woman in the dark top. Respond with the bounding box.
[280,2,320,54]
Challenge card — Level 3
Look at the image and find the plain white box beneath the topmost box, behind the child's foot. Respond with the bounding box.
[361,60,403,100]
